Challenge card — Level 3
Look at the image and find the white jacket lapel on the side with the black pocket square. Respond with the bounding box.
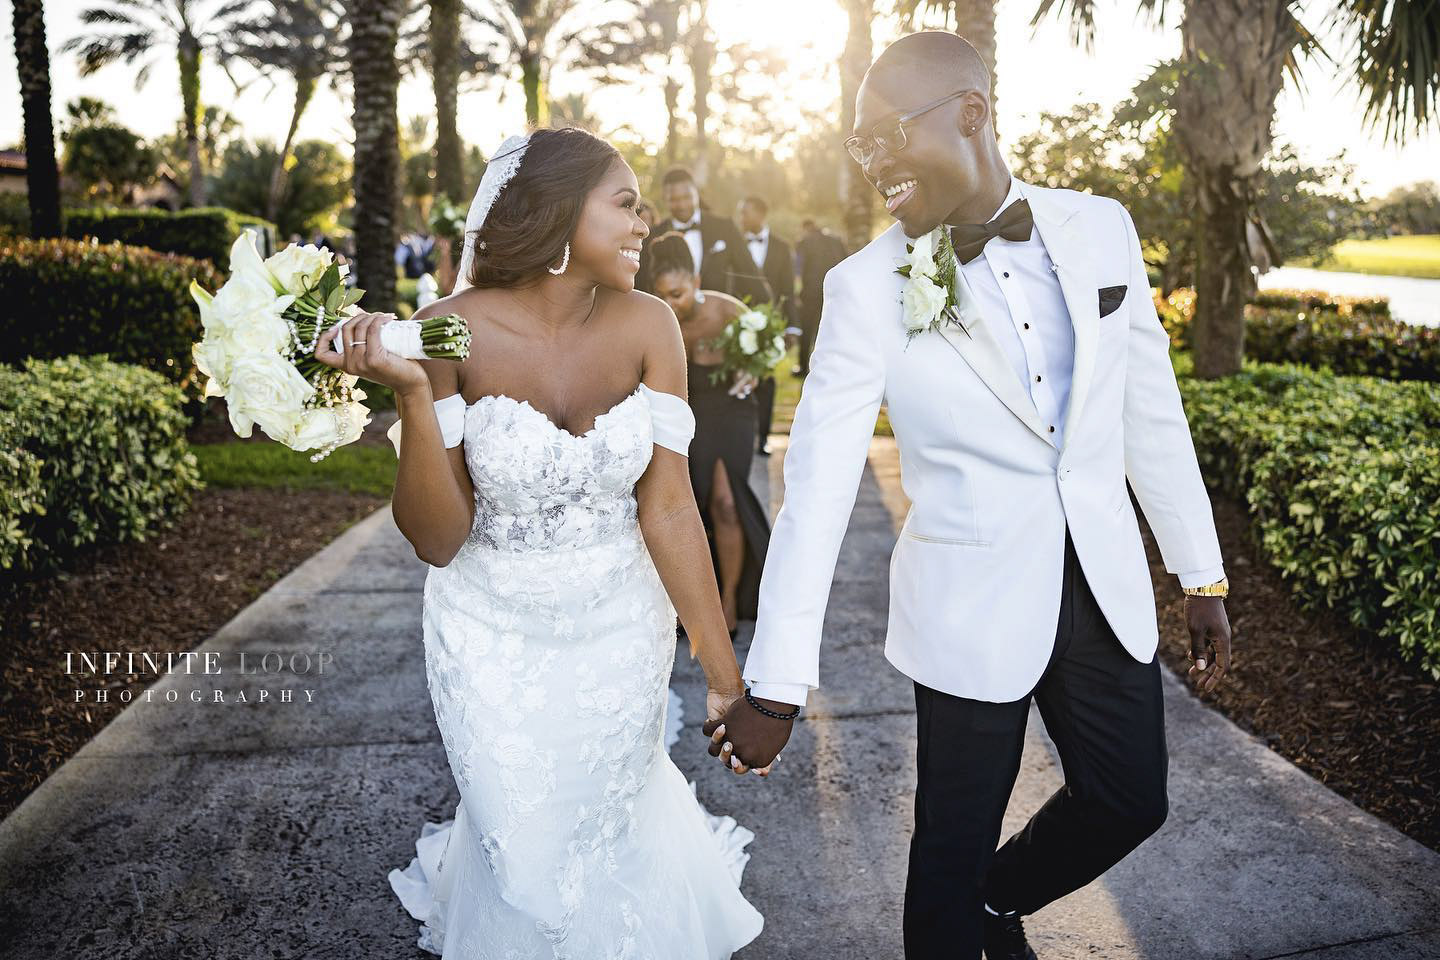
[1021,184,1100,445]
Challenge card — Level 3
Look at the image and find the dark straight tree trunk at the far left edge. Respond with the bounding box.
[13,0,60,236]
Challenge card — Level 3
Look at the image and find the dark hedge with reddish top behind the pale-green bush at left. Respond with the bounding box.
[0,237,220,397]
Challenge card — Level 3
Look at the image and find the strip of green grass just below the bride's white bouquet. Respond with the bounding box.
[190,440,396,498]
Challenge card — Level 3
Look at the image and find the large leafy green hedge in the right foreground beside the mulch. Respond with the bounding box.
[1181,364,1440,679]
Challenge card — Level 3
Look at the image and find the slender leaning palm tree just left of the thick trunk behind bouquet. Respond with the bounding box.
[217,0,347,220]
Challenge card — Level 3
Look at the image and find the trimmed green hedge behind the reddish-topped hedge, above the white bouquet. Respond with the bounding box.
[65,207,275,273]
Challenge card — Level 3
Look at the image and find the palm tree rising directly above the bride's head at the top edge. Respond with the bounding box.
[471,0,634,125]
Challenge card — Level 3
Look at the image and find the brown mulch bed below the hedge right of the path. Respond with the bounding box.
[1142,498,1440,851]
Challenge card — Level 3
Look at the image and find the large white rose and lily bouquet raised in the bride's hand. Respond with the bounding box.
[190,238,469,462]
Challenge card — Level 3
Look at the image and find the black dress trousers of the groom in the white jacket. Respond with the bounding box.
[904,531,1168,960]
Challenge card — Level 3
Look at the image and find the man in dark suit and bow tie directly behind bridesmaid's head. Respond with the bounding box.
[635,167,770,304]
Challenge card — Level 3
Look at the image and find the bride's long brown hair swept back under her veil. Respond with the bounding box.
[467,127,621,286]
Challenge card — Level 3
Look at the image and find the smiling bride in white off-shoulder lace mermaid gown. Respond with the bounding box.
[315,130,766,960]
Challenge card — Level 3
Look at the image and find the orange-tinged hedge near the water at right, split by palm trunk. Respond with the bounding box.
[1155,289,1440,381]
